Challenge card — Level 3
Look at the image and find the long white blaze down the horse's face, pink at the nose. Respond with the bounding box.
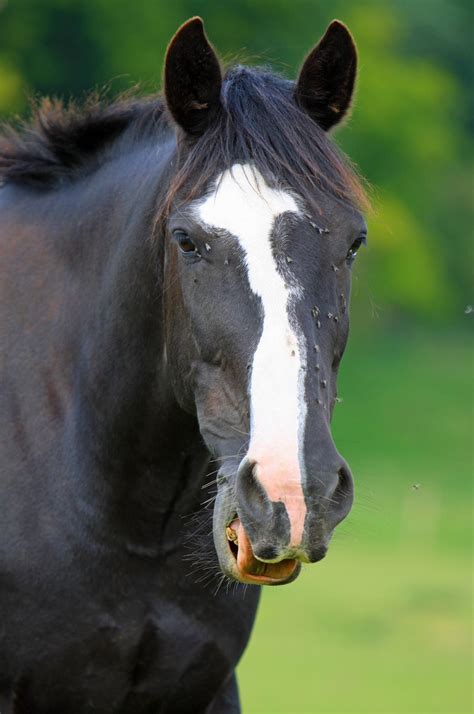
[197,164,306,546]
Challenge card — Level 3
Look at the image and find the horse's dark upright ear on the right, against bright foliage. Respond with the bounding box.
[295,20,357,131]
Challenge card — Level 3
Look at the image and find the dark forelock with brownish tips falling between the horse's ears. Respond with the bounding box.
[163,66,369,222]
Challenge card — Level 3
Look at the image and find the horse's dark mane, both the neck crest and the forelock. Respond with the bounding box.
[0,66,367,208]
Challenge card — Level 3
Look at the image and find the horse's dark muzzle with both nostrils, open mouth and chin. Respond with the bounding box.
[214,450,353,585]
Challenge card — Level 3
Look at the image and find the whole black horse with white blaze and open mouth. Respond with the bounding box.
[0,18,366,714]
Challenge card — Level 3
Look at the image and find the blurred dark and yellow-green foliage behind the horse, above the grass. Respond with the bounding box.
[0,0,474,326]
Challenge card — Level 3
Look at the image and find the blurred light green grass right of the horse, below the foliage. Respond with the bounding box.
[239,332,473,714]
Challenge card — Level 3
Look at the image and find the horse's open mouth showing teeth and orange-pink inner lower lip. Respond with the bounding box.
[226,516,300,585]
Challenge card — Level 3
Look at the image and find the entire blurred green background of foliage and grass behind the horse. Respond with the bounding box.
[0,0,474,714]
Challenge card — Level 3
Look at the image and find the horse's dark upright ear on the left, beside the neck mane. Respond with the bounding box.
[164,17,222,136]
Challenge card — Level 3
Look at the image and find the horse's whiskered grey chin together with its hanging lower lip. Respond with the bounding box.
[213,489,301,585]
